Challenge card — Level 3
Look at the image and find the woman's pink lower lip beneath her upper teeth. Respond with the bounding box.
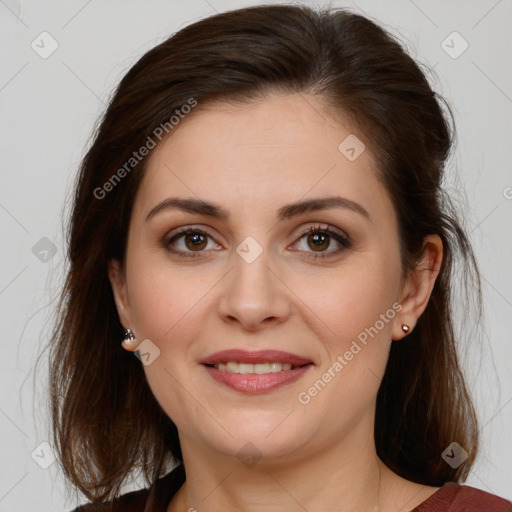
[204,364,313,395]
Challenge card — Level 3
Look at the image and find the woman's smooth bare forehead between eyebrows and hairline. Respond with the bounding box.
[135,94,390,224]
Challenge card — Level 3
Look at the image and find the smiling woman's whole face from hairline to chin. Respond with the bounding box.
[110,95,418,459]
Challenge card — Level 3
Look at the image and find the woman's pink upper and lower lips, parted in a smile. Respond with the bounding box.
[201,349,313,395]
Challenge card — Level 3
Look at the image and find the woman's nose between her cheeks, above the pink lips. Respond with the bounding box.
[218,247,290,331]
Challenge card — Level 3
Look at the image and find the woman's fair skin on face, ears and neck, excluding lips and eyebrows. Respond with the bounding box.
[109,95,443,512]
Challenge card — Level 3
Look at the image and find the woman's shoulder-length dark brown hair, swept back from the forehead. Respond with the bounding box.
[46,5,481,502]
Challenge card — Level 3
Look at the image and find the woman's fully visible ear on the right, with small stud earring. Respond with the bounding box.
[392,235,443,340]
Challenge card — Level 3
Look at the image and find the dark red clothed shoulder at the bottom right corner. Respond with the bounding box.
[411,482,512,512]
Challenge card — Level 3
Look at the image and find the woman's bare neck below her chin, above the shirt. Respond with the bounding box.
[168,424,419,512]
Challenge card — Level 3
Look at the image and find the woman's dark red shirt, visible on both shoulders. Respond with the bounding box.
[72,465,512,512]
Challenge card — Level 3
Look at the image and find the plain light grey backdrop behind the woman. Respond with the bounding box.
[0,0,512,512]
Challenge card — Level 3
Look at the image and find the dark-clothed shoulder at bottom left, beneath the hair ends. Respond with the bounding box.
[71,464,185,512]
